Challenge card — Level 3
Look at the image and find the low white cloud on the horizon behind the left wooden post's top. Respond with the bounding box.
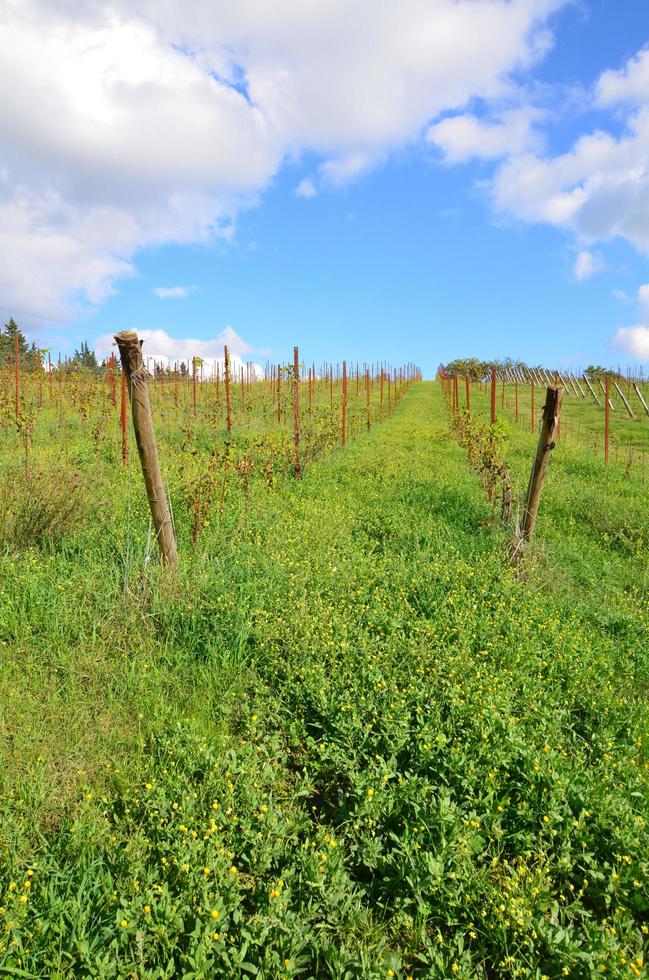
[95,327,264,377]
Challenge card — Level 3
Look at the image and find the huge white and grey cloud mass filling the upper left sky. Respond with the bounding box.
[0,0,566,316]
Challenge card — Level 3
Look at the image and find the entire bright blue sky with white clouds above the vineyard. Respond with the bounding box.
[0,0,649,376]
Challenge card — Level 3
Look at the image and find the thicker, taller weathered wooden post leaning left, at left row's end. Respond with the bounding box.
[115,330,178,565]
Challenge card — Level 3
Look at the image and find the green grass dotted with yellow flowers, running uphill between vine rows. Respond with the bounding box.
[0,383,649,980]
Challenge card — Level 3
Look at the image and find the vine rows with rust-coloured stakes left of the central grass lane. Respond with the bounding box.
[0,338,419,560]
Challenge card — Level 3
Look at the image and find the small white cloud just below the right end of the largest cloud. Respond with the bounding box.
[426,106,545,163]
